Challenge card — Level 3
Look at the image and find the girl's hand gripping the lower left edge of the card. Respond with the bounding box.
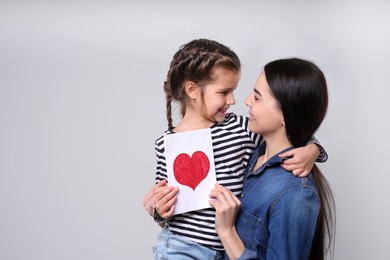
[143,180,179,219]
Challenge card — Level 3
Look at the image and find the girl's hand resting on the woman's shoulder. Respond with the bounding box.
[279,143,320,177]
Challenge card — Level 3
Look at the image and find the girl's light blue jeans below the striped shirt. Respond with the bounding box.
[153,228,224,260]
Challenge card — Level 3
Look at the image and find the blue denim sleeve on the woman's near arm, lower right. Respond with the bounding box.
[266,186,320,260]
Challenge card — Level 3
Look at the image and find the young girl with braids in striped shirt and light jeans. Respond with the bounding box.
[144,39,326,259]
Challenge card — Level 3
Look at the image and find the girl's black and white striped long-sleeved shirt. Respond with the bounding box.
[155,113,261,250]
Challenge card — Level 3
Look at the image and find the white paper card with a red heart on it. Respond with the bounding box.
[165,128,216,214]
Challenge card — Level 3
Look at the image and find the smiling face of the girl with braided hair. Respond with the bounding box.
[201,68,240,122]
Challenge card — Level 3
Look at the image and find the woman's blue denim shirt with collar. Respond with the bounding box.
[236,143,320,260]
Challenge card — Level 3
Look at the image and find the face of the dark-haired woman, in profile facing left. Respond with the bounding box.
[245,72,284,137]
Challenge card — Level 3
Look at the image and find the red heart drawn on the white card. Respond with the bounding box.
[173,151,210,190]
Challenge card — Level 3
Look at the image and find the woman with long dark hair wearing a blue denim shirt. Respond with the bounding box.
[210,58,334,260]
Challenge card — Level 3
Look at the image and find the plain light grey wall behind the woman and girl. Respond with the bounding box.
[0,0,390,260]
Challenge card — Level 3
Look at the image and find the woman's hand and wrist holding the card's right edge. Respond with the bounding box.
[209,184,241,237]
